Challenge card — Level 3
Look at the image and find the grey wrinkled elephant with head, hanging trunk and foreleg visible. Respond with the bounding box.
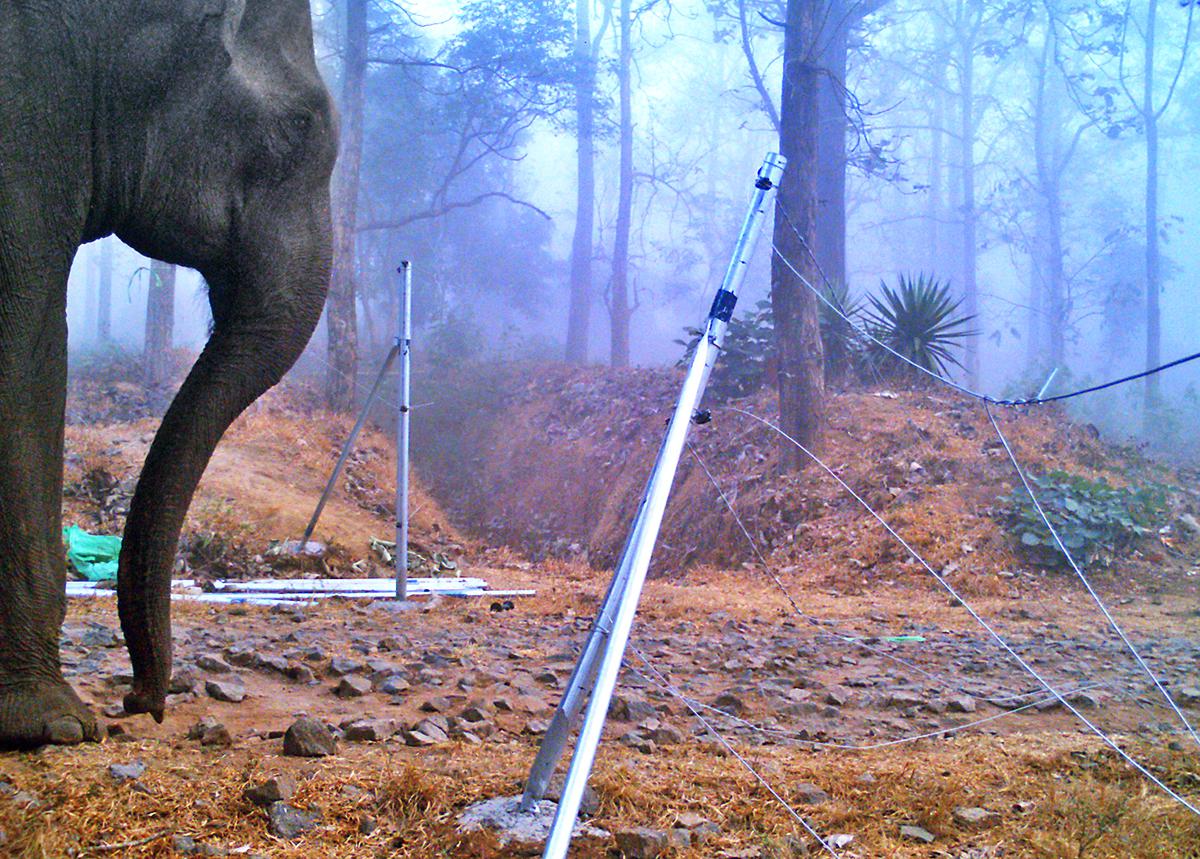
[0,0,336,749]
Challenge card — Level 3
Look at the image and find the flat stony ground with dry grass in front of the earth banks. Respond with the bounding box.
[0,565,1200,859]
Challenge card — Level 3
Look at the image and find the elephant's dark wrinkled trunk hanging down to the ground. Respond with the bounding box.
[118,247,329,721]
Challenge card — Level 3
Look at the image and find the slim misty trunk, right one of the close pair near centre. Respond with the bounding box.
[608,0,634,367]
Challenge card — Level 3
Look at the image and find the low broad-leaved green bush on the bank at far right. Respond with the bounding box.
[998,471,1166,566]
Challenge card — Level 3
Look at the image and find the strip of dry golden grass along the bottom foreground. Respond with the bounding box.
[0,734,1200,859]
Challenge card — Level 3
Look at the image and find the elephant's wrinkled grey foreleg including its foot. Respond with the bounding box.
[0,239,97,749]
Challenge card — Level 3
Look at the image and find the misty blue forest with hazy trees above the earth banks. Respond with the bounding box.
[70,0,1200,463]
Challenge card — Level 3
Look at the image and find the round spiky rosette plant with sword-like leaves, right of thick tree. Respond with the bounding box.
[865,275,976,374]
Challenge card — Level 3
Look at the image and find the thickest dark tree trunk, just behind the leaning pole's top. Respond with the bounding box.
[770,0,824,469]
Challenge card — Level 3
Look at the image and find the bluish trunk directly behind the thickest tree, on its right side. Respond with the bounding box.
[814,0,844,291]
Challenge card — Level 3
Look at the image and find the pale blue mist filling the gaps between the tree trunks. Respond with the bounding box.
[68,0,1200,448]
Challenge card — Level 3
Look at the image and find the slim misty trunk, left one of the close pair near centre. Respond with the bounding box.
[566,0,596,364]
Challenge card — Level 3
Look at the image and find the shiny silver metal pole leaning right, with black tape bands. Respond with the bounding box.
[537,152,787,859]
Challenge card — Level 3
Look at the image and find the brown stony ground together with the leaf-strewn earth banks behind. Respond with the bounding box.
[0,371,1200,859]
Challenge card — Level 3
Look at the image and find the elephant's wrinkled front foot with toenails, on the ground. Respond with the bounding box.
[0,680,100,750]
